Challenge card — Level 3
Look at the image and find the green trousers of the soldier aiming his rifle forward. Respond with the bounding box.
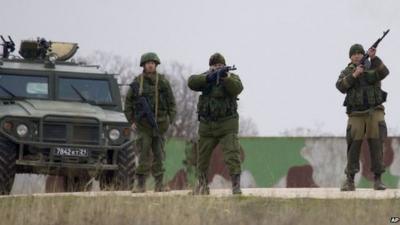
[197,118,241,177]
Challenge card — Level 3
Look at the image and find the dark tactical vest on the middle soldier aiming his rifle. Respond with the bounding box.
[197,83,238,121]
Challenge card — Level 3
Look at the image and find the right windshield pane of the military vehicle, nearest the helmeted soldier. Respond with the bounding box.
[58,78,113,104]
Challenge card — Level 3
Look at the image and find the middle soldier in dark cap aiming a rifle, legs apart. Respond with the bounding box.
[188,53,243,194]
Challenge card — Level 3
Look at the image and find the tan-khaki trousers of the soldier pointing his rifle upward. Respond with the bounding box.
[345,110,387,175]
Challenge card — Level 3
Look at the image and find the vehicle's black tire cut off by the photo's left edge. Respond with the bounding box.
[0,138,17,195]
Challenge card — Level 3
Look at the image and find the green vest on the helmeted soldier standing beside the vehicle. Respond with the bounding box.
[134,74,168,122]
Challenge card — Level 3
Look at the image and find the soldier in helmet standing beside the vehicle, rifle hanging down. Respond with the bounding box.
[125,52,176,192]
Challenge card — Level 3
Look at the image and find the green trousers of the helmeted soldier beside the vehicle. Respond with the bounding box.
[136,123,165,177]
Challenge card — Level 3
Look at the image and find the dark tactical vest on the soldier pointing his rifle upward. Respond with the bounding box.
[343,65,387,112]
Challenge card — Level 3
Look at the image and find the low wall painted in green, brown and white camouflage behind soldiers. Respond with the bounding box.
[166,137,400,189]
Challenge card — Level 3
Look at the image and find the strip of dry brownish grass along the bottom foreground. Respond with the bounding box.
[0,196,400,225]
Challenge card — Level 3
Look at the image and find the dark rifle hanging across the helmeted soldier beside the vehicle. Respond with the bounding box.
[129,82,160,134]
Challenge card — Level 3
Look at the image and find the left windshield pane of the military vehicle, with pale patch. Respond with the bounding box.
[0,74,49,99]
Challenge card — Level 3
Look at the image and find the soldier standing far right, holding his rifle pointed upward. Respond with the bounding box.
[336,44,389,191]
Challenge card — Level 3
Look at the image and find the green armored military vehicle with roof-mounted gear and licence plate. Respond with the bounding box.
[0,36,135,194]
